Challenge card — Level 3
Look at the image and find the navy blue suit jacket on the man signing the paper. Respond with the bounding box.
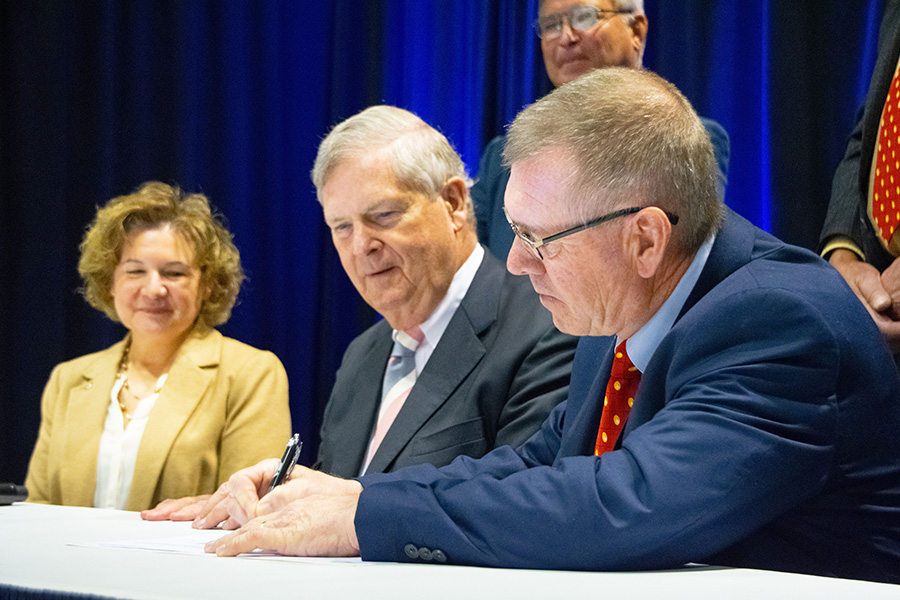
[355,211,900,582]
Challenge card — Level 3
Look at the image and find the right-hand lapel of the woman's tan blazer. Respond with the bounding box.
[128,329,222,508]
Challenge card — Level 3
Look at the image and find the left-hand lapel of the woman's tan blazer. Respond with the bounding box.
[60,340,125,506]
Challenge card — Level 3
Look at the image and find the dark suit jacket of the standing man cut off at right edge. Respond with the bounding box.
[819,0,900,272]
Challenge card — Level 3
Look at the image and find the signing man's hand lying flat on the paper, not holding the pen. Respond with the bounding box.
[205,481,362,556]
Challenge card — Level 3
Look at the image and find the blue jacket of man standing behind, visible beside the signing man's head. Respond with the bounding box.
[472,119,731,259]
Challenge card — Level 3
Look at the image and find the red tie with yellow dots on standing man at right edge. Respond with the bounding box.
[869,62,900,255]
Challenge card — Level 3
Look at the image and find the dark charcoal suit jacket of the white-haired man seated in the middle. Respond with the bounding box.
[316,252,576,477]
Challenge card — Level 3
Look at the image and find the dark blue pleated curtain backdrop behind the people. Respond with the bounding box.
[0,0,881,482]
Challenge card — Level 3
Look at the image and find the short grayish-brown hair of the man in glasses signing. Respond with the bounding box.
[503,67,723,253]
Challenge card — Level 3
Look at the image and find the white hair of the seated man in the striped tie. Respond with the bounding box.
[311,105,474,221]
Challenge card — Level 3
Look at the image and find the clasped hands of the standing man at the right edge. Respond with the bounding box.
[828,249,900,353]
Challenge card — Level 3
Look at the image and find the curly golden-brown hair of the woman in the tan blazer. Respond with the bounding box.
[78,181,244,327]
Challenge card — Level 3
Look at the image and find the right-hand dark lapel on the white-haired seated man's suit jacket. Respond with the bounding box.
[366,252,504,473]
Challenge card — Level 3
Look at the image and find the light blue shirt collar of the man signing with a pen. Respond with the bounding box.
[616,234,716,373]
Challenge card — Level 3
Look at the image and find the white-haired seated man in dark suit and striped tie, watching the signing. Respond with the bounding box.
[143,106,576,520]
